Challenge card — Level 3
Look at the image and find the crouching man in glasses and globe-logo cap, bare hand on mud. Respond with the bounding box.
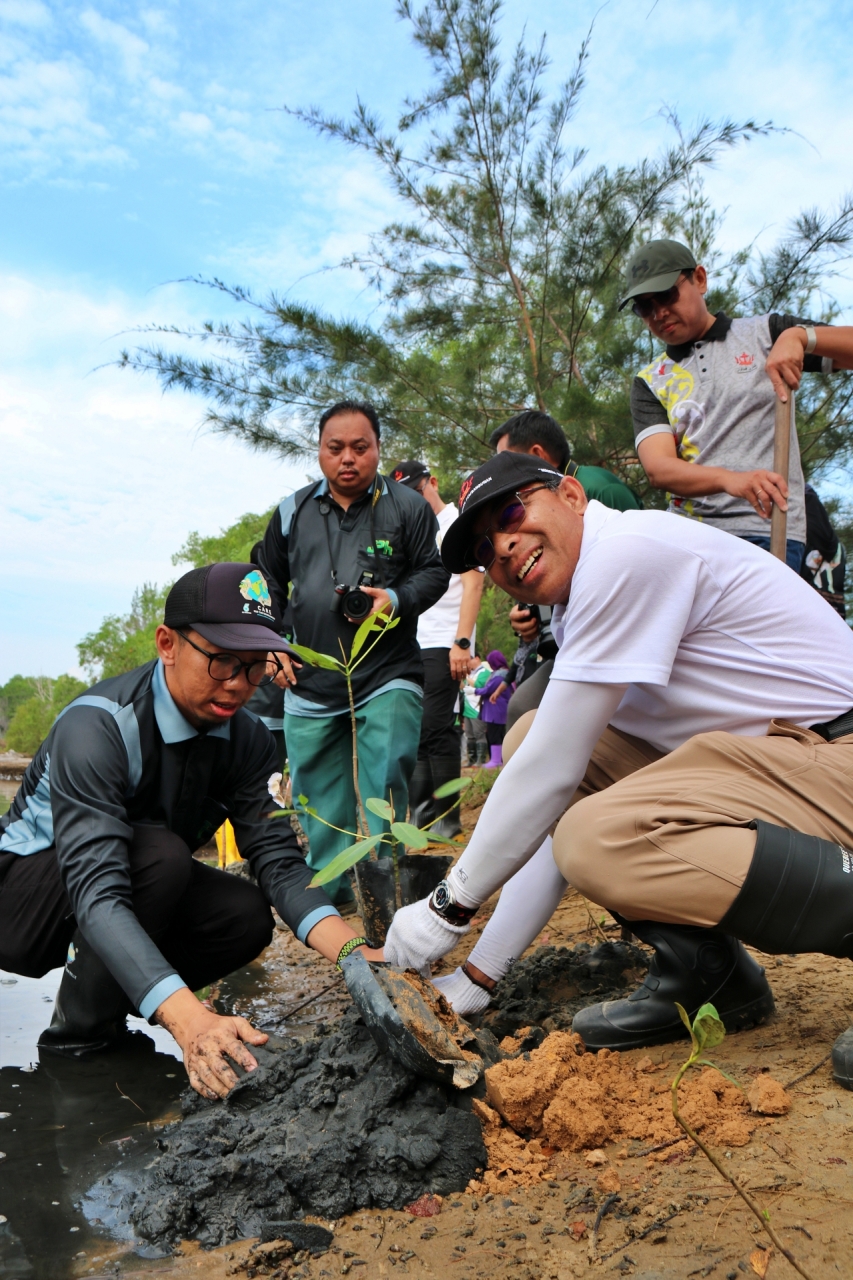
[0,564,379,1097]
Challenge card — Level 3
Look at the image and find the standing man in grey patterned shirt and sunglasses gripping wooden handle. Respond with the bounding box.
[620,239,853,572]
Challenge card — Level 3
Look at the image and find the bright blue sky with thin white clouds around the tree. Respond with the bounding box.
[0,0,853,681]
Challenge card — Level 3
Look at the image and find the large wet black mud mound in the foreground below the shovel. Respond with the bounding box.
[127,1010,487,1247]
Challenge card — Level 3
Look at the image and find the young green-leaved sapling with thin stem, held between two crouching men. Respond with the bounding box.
[263,613,470,890]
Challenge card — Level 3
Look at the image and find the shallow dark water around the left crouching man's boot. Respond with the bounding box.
[0,969,180,1280]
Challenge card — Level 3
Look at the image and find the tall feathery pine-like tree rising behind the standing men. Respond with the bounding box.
[123,0,853,502]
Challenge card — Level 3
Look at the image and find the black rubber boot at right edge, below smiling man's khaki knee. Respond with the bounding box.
[720,822,853,1089]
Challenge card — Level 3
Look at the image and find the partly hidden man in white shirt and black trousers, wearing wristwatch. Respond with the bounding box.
[391,458,483,840]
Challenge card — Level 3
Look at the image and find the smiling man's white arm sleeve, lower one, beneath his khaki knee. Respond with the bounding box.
[466,836,569,983]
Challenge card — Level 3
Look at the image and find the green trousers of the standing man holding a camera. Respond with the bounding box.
[284,689,423,902]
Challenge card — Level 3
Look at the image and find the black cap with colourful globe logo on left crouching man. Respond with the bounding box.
[163,564,289,653]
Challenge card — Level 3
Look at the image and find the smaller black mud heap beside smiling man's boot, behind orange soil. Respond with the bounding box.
[482,942,648,1039]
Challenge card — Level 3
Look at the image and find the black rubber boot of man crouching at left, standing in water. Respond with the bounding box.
[38,929,134,1057]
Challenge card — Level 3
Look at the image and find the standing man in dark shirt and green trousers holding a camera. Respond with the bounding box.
[252,401,450,905]
